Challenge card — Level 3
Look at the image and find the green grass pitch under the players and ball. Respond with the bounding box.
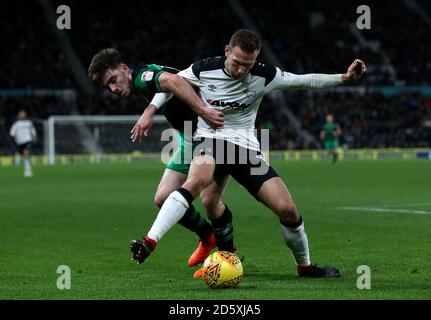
[0,160,431,300]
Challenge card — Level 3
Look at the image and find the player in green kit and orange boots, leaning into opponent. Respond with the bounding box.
[88,48,228,276]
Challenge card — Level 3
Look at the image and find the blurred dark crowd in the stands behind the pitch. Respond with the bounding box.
[0,0,431,149]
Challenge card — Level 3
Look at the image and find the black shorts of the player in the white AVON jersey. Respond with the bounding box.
[193,138,278,199]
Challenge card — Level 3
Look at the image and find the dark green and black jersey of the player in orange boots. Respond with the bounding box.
[132,64,198,132]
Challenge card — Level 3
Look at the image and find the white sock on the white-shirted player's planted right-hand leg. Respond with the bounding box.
[281,222,311,267]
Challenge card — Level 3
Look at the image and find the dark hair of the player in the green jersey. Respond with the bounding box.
[88,48,124,83]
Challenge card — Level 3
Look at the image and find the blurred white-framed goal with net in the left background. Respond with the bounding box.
[44,115,171,164]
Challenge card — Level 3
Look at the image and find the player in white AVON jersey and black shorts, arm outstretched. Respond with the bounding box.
[131,29,366,278]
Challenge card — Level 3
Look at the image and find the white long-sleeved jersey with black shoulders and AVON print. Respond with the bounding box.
[153,57,342,150]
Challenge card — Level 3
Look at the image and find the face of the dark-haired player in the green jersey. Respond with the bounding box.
[102,64,132,98]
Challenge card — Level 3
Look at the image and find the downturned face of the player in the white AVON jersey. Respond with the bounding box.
[225,46,259,79]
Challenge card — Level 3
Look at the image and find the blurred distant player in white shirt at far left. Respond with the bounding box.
[9,110,37,177]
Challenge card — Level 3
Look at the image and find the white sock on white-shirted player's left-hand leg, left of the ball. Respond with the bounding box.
[148,191,189,242]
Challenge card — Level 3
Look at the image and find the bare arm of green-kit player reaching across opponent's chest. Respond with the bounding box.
[159,72,224,129]
